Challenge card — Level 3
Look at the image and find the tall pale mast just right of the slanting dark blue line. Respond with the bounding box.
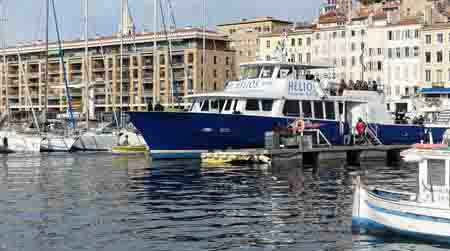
[84,0,90,129]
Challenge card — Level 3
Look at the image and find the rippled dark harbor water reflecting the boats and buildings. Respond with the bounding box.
[0,154,450,251]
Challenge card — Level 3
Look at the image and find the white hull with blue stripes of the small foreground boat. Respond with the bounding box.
[352,177,450,243]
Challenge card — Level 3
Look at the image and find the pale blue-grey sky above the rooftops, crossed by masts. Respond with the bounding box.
[0,0,322,46]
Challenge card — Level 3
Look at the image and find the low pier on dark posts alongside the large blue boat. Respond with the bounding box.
[202,145,411,168]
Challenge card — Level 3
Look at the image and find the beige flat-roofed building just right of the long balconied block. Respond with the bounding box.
[217,17,292,78]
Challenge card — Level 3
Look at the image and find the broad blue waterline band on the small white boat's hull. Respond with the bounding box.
[352,217,450,244]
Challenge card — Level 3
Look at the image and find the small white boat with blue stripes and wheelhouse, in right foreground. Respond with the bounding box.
[352,145,450,243]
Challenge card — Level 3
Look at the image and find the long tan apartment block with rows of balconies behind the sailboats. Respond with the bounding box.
[0,28,234,112]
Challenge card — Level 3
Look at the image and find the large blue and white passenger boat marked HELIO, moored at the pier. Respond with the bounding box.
[129,61,445,158]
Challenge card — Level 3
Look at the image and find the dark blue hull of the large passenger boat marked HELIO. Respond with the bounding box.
[130,112,343,158]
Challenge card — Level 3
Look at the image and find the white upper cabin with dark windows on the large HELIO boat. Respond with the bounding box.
[187,61,391,124]
